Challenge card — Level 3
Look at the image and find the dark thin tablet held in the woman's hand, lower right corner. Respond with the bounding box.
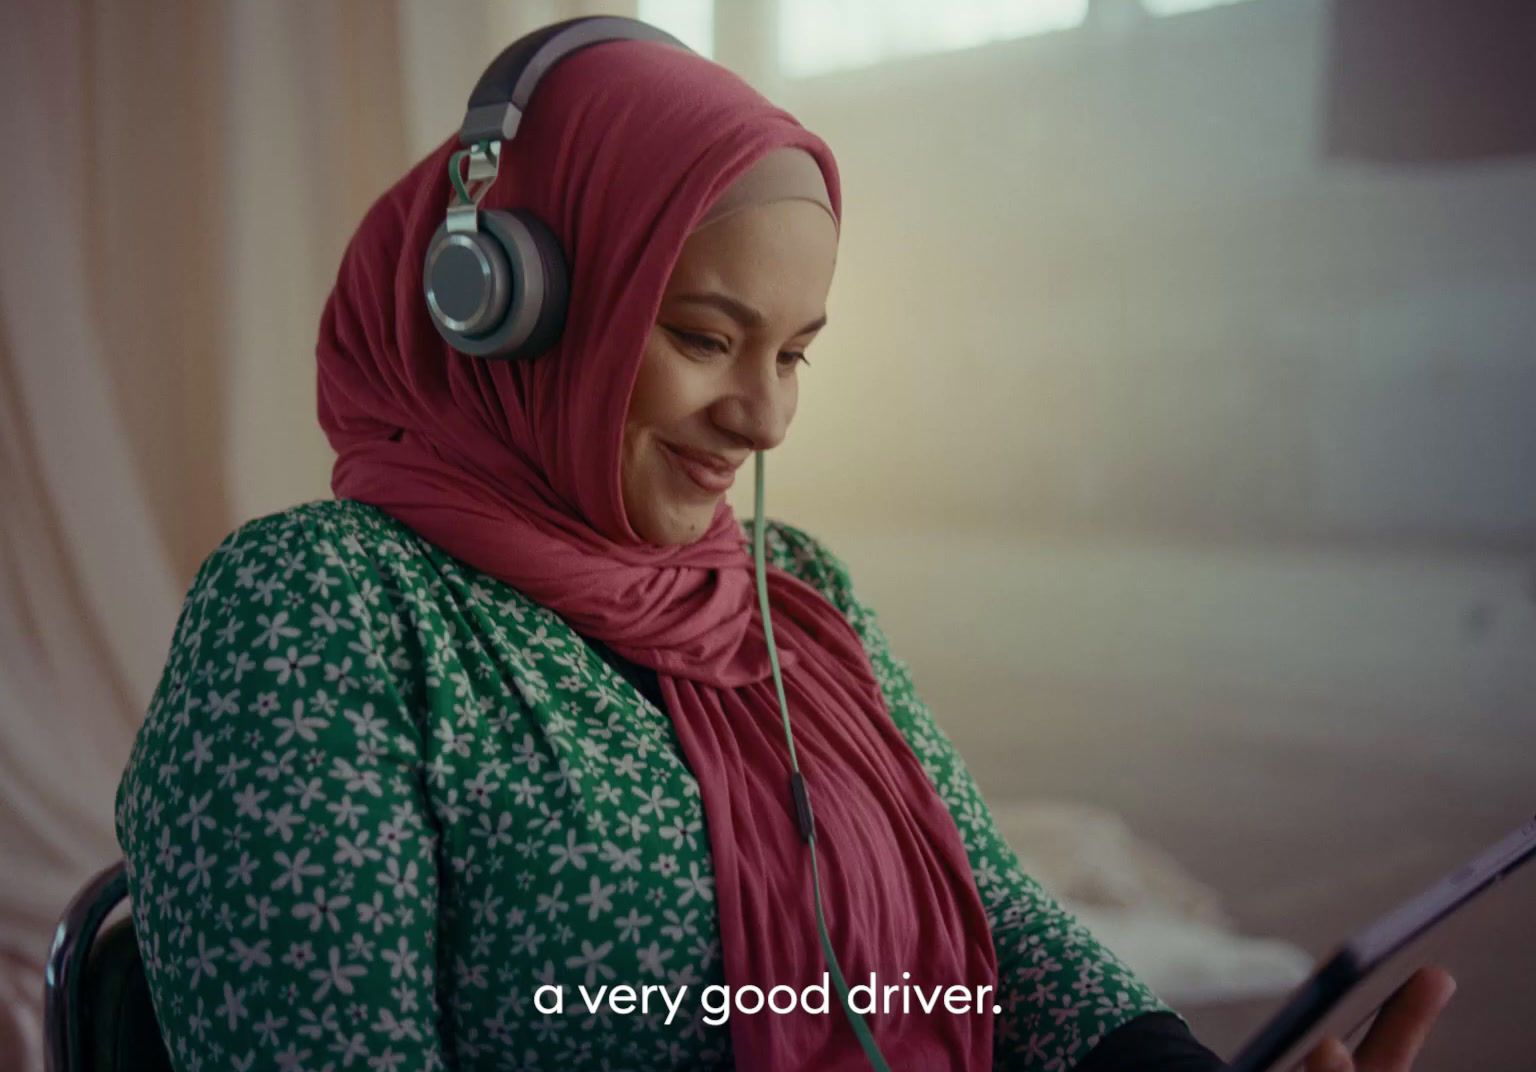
[1227,819,1536,1072]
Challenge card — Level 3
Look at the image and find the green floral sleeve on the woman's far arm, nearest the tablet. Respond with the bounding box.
[758,522,1187,1072]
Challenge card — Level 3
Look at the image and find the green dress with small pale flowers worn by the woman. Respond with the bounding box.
[117,499,1172,1072]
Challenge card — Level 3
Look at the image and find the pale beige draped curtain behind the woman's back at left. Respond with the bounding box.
[0,0,624,1069]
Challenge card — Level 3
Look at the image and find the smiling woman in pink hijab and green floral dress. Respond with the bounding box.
[117,18,1449,1070]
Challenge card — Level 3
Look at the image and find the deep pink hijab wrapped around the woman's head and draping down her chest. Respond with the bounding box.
[318,41,997,1072]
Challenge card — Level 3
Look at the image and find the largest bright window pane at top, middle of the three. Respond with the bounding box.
[779,0,1093,78]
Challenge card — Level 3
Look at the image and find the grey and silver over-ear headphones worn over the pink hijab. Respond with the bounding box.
[422,15,691,361]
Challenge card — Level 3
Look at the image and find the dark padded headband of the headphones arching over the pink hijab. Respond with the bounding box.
[459,15,691,146]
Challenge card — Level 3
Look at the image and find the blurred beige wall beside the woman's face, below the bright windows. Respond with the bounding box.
[737,0,1536,547]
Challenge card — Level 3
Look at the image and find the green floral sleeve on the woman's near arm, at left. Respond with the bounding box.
[117,516,447,1072]
